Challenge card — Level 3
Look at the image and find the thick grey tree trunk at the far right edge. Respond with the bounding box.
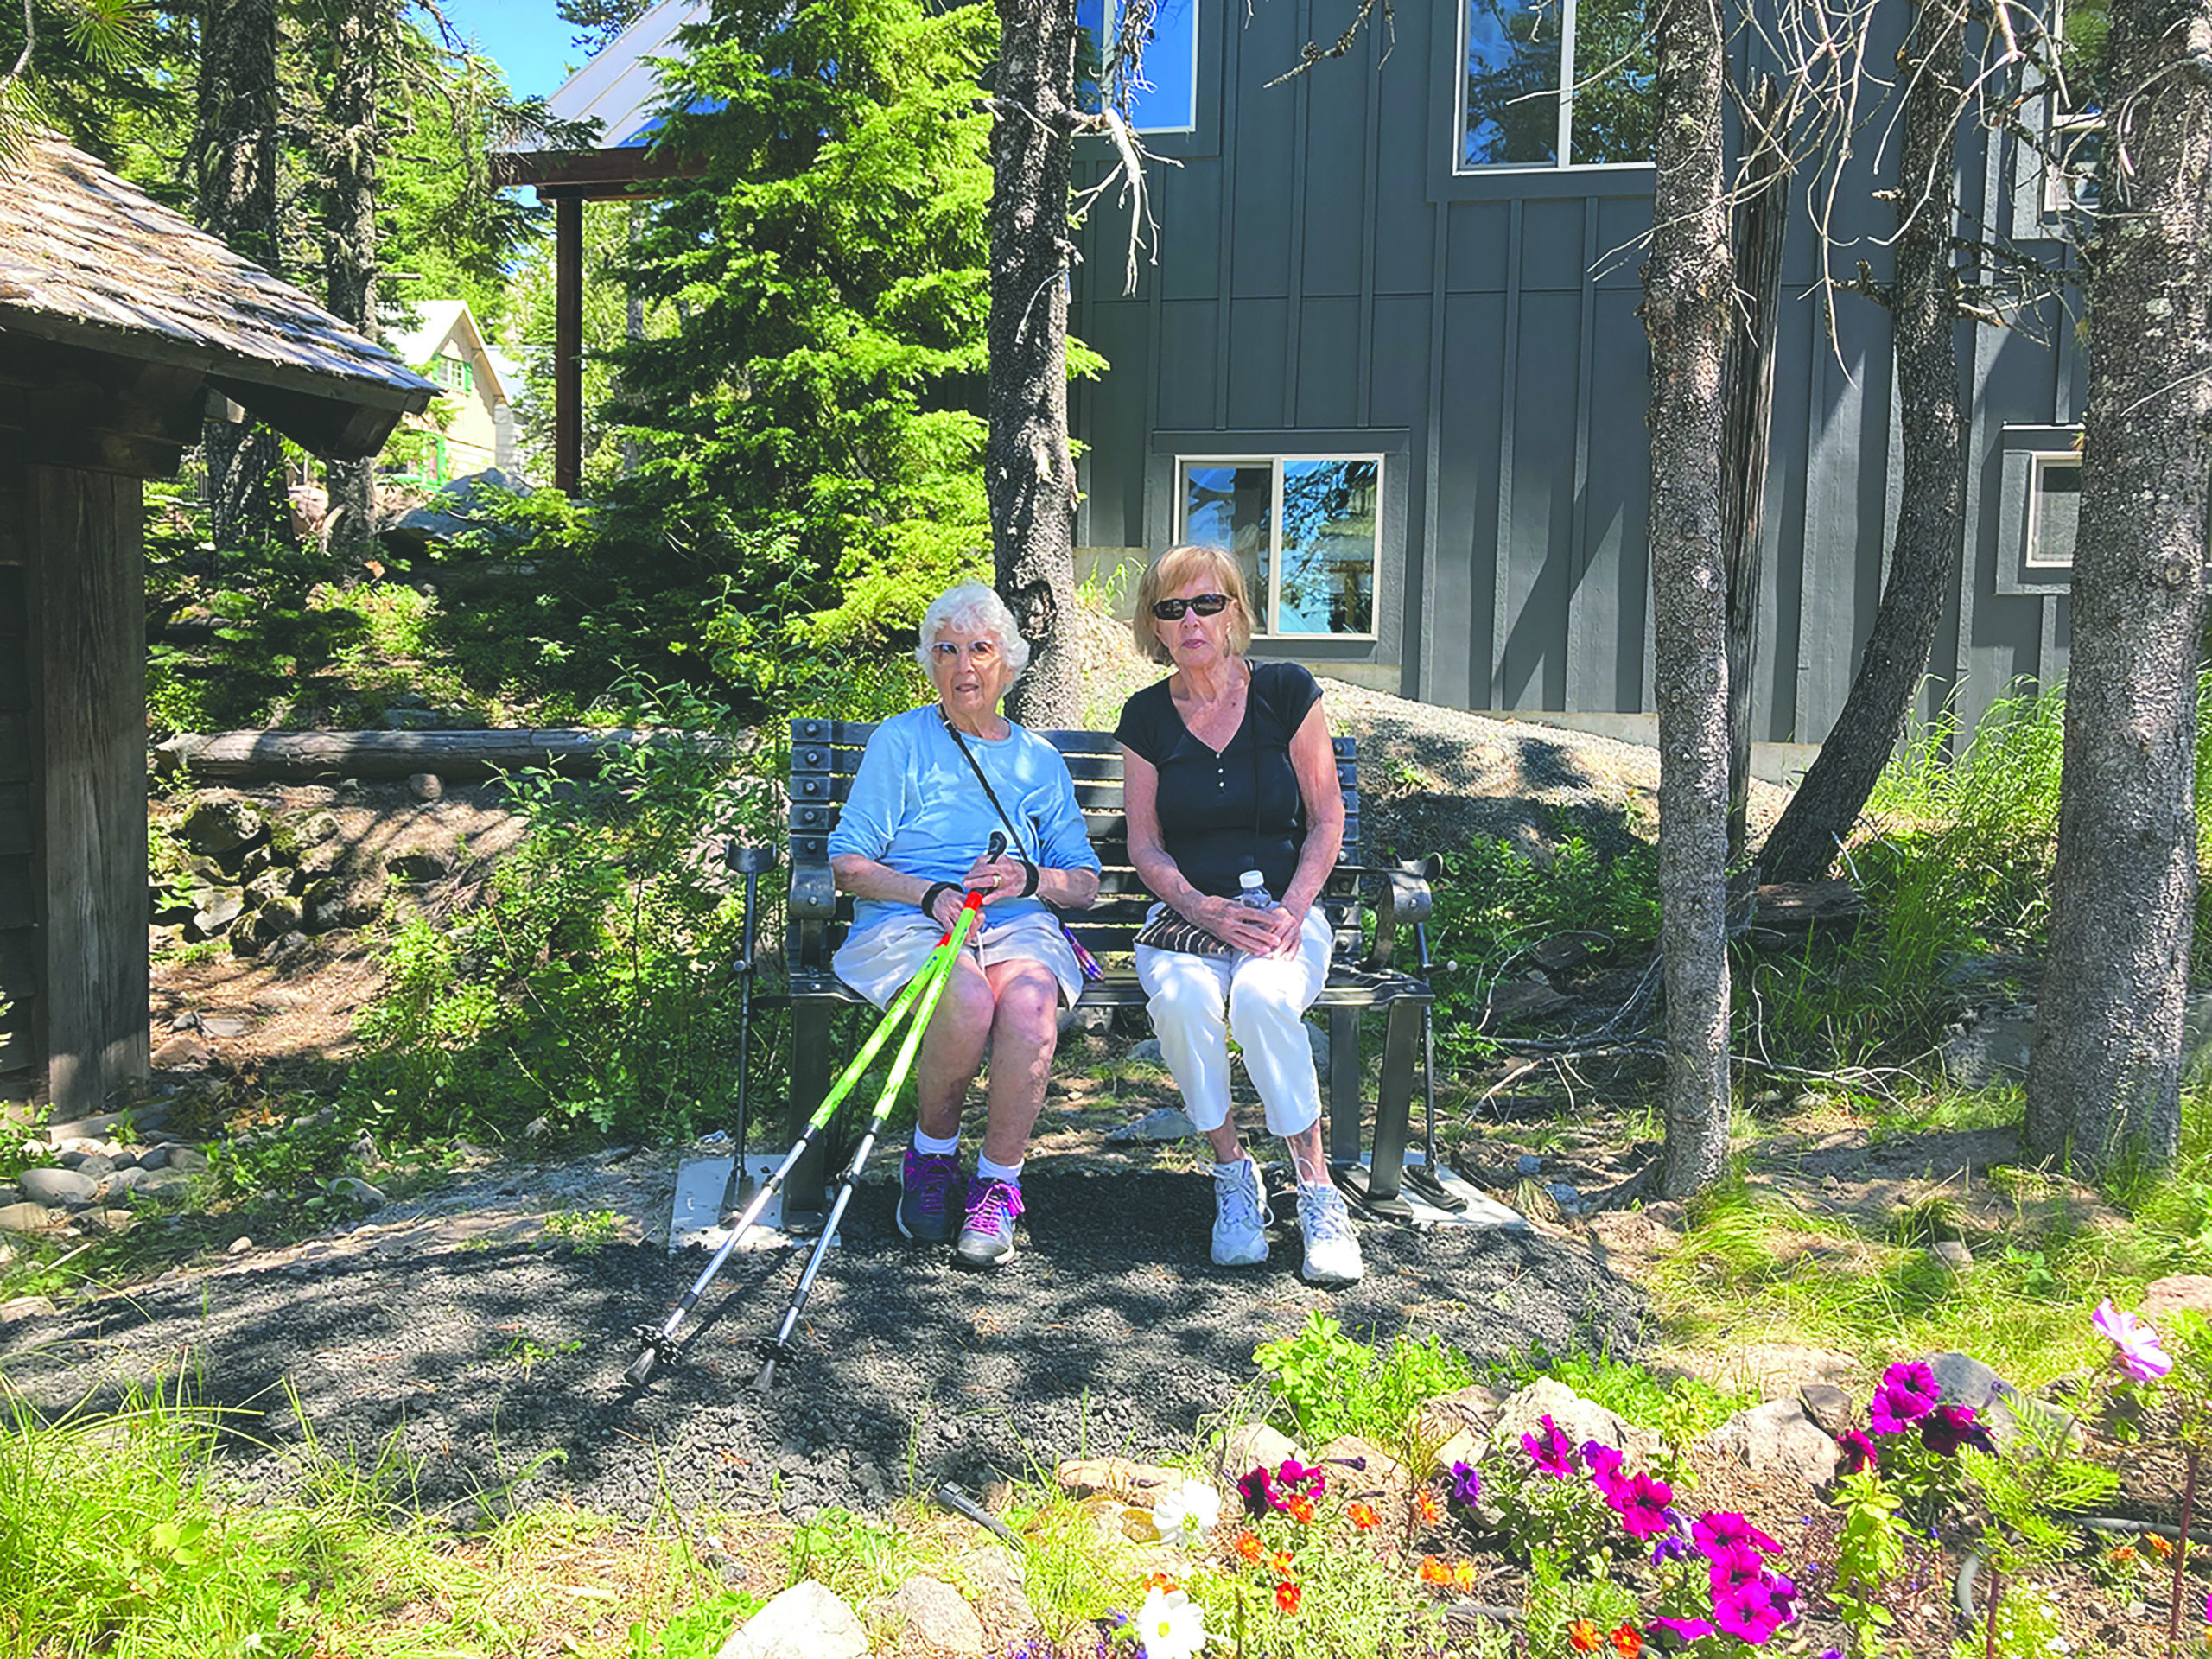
[2029,0,2212,1177]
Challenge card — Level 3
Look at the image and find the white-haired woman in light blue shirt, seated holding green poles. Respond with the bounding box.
[830,582,1099,1268]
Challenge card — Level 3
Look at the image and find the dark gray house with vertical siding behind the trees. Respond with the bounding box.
[1071,0,2082,743]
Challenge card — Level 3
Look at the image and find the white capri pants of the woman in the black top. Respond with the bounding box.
[1137,905,1332,1137]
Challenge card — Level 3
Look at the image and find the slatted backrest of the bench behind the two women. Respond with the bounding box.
[785,719,1360,971]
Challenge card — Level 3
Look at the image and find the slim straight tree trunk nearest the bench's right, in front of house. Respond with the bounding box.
[1643,0,1737,1197]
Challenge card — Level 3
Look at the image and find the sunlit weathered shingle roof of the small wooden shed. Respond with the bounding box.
[0,137,438,471]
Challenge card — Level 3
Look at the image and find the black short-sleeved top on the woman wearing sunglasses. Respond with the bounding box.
[1115,661,1320,898]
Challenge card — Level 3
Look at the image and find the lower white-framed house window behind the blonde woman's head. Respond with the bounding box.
[1177,455,1382,637]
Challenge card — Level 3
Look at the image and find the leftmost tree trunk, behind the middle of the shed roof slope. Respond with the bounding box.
[193,0,289,553]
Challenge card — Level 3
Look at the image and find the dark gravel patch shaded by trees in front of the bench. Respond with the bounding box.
[0,1173,1648,1520]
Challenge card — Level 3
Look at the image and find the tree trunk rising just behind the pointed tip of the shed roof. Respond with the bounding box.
[323,0,387,560]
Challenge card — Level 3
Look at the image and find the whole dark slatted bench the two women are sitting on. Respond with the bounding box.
[785,719,1433,1214]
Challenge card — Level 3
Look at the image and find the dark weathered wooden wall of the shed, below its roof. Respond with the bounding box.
[0,460,149,1113]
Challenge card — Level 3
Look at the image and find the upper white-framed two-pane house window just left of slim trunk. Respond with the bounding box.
[1458,0,1652,170]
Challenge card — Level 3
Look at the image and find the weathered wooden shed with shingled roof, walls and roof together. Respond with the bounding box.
[0,139,435,1113]
